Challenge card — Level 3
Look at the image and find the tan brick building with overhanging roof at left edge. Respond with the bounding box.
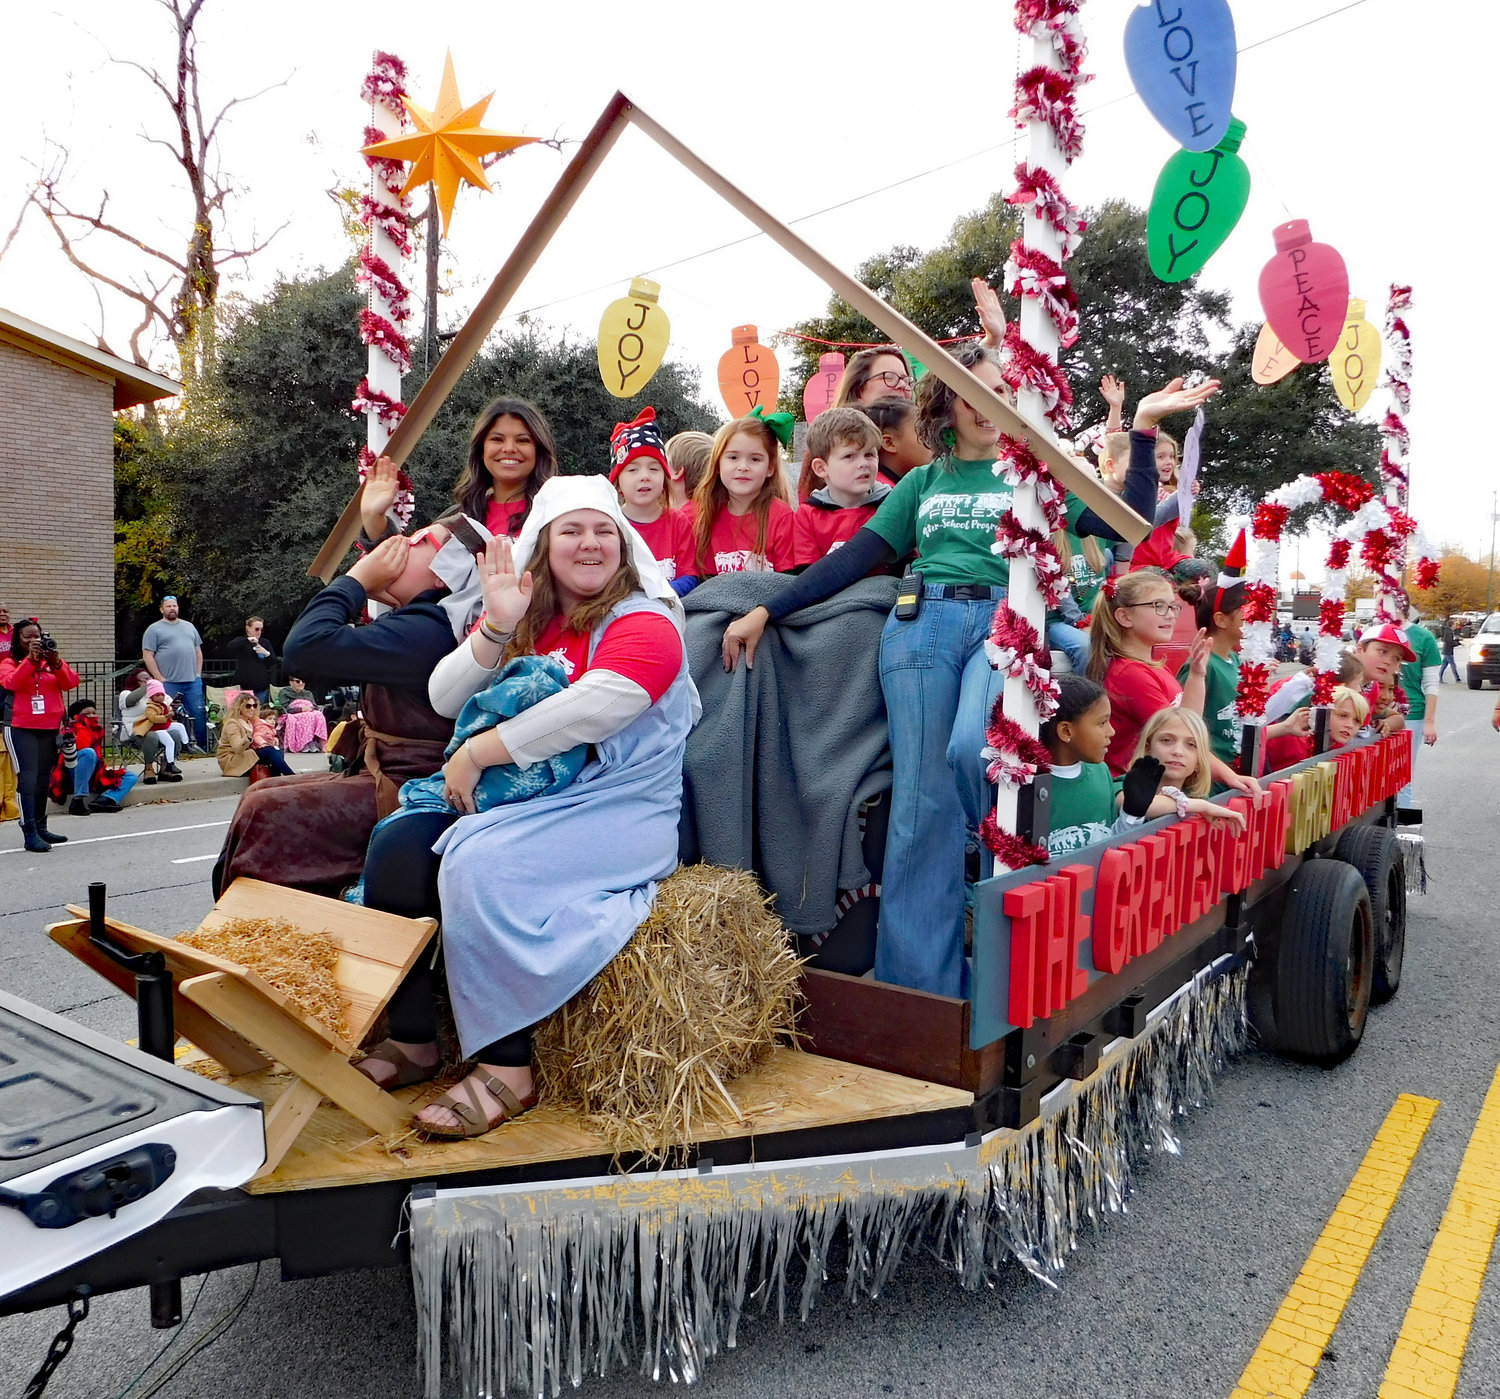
[0,309,182,660]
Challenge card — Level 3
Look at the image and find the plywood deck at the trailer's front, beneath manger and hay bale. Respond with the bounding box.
[208,1050,974,1194]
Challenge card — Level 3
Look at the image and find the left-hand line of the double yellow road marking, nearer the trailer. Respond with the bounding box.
[1230,1093,1437,1399]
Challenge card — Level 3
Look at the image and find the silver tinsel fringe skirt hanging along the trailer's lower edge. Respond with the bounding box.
[411,967,1247,1399]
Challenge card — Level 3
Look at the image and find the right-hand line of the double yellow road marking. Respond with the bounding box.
[1380,1072,1500,1399]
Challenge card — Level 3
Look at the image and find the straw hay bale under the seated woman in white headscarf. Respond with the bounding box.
[534,865,801,1156]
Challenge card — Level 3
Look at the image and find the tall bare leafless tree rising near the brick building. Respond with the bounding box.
[22,0,287,382]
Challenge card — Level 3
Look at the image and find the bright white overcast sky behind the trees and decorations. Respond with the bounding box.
[0,0,1500,577]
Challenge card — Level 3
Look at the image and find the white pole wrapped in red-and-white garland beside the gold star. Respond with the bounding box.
[350,52,417,529]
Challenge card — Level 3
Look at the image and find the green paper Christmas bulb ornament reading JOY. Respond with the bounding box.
[1146,121,1250,282]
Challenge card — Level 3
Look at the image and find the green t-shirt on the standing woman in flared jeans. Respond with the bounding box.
[867,457,1085,586]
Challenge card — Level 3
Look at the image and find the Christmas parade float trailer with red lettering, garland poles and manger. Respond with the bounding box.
[0,0,1425,1396]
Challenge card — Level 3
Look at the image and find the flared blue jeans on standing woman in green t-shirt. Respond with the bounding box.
[875,591,1004,996]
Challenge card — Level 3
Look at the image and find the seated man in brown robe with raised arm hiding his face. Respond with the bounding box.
[213,522,483,897]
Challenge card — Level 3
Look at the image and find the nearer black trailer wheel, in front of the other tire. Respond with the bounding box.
[1275,859,1376,1065]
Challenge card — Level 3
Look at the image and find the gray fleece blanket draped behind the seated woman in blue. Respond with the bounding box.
[683,573,896,934]
